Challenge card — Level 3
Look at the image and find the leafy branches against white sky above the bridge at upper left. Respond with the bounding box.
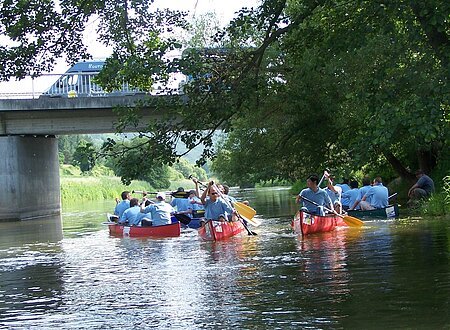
[0,0,186,87]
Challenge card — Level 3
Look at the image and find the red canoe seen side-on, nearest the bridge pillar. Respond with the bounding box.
[108,222,181,237]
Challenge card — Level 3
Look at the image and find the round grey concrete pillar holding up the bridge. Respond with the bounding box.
[0,136,61,221]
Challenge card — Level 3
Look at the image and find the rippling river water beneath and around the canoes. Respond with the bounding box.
[0,188,450,329]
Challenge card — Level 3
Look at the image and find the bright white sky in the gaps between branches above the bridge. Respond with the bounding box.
[0,0,259,98]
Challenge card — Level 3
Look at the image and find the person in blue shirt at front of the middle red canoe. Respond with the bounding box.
[200,181,233,221]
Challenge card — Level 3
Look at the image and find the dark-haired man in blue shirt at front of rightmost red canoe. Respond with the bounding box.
[295,174,333,215]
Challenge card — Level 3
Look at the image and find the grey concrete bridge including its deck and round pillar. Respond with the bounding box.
[0,96,176,221]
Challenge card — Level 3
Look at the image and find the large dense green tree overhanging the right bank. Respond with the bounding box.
[212,1,449,183]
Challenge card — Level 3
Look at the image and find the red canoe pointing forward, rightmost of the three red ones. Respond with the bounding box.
[291,211,346,235]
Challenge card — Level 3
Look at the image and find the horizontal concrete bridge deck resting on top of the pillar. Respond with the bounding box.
[0,95,175,135]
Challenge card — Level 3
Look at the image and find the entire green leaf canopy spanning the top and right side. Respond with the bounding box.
[0,0,450,186]
